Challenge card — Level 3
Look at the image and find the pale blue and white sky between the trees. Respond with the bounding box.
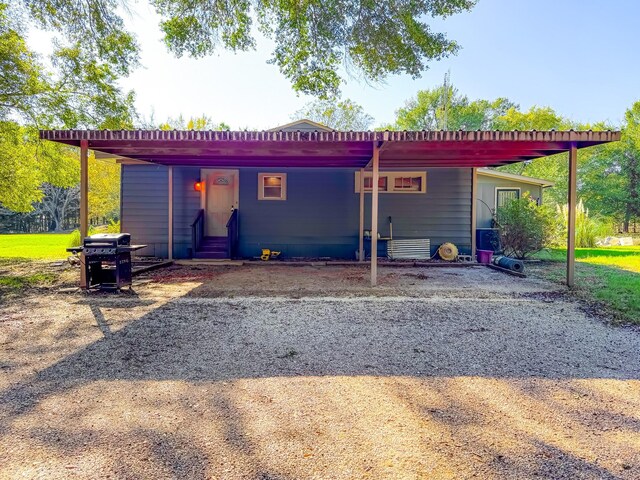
[32,0,640,129]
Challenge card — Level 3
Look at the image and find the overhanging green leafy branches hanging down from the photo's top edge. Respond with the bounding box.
[12,0,476,98]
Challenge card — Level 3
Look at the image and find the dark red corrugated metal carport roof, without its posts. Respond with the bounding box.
[40,130,620,169]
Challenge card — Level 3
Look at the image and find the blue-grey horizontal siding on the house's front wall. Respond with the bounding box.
[122,165,471,258]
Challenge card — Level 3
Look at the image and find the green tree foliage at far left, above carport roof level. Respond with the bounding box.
[0,1,134,126]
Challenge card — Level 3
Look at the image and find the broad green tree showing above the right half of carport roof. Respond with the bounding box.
[391,85,515,130]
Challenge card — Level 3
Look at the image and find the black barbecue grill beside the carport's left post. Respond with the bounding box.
[67,233,146,290]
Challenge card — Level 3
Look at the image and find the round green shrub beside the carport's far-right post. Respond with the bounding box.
[497,193,554,259]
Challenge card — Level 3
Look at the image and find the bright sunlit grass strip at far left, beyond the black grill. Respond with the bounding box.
[0,233,70,260]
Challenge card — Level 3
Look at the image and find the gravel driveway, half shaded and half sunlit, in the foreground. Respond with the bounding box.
[0,265,640,480]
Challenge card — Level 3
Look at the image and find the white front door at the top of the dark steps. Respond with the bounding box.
[201,170,239,237]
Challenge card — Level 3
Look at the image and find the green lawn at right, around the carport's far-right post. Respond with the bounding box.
[532,246,640,324]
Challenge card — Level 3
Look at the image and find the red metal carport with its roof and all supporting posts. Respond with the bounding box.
[40,130,620,286]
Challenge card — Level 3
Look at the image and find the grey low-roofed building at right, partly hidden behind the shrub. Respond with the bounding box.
[476,168,554,228]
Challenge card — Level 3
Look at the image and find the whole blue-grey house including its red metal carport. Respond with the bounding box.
[40,120,620,284]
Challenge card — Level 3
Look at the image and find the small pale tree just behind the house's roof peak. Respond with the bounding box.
[291,99,373,131]
